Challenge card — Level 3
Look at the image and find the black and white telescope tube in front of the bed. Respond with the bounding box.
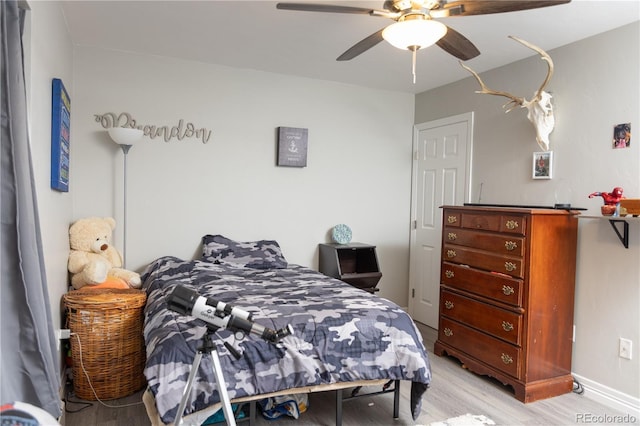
[168,286,293,343]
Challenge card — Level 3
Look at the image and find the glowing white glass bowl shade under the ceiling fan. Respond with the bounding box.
[382,19,447,50]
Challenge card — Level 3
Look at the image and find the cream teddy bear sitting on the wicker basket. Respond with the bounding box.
[68,217,142,290]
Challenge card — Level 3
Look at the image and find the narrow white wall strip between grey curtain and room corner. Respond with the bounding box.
[24,1,75,336]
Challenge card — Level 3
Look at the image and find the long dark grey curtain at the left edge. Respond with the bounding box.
[0,0,61,418]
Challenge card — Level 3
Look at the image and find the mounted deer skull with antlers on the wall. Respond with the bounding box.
[460,36,555,151]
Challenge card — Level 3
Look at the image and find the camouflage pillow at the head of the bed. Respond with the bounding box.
[202,235,287,269]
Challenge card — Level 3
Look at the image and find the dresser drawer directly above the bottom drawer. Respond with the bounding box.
[440,289,522,345]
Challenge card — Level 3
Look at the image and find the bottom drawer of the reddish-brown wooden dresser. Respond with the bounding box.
[438,317,522,378]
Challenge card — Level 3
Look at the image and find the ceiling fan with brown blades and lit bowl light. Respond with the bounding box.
[276,0,571,82]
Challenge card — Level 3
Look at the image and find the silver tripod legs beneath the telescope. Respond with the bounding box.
[173,329,236,426]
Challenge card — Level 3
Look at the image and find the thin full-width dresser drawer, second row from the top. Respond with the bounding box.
[443,227,525,256]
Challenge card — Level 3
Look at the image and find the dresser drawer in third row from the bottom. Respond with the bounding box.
[440,262,522,306]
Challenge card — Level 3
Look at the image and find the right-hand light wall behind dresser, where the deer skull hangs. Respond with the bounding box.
[415,22,640,407]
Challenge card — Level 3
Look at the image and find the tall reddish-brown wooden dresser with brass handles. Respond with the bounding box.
[434,206,578,402]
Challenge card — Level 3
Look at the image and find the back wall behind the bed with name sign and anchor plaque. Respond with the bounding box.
[70,47,414,305]
